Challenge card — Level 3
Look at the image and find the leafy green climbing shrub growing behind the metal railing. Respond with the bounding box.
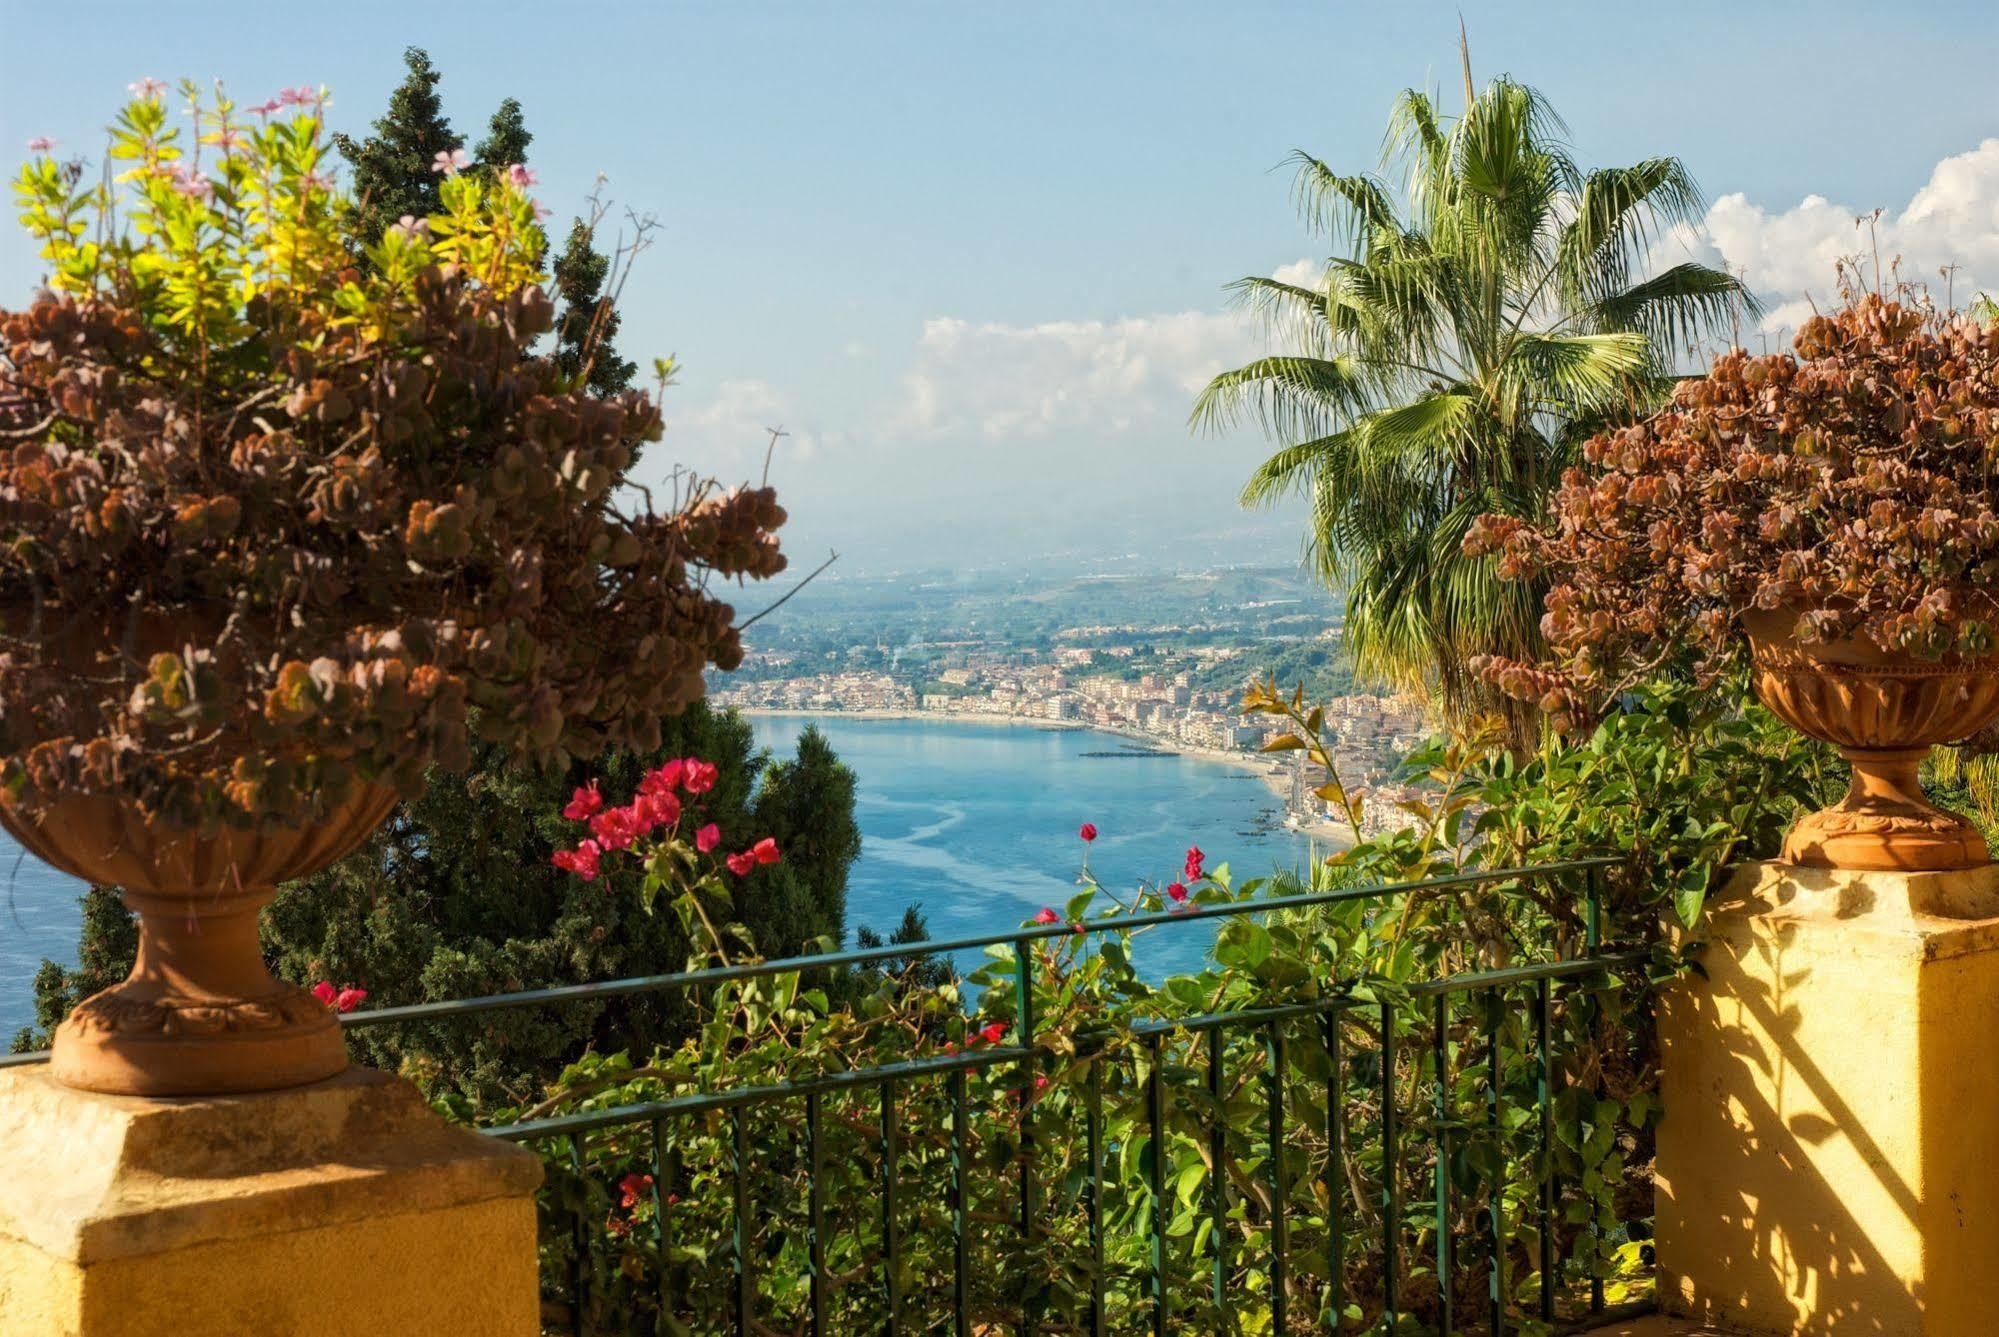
[503,683,1827,1333]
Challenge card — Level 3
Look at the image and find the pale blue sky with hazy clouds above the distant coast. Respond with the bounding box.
[0,0,1999,574]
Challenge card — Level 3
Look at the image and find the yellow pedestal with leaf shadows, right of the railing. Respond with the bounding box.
[1657,863,1999,1337]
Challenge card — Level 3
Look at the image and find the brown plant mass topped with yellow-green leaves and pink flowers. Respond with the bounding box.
[0,90,784,827]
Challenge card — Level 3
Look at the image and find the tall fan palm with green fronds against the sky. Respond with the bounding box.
[1193,60,1755,737]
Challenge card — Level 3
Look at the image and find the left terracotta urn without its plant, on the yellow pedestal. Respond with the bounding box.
[0,785,396,1095]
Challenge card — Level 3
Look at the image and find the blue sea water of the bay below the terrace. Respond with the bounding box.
[0,715,1309,1049]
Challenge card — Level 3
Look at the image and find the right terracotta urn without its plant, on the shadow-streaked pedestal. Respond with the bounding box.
[1743,610,1999,871]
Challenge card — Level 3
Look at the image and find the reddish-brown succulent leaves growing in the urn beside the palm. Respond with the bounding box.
[1465,294,1999,721]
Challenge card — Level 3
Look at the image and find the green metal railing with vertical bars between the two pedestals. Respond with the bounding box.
[0,857,1645,1337]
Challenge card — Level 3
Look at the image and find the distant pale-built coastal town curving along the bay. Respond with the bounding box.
[714,644,1423,841]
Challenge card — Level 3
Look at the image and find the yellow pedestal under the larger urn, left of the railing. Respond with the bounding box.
[0,1067,542,1337]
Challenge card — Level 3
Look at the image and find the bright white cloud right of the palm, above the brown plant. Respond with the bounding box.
[1669,138,1999,328]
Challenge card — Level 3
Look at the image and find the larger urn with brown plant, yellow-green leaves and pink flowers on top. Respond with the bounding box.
[0,80,784,1095]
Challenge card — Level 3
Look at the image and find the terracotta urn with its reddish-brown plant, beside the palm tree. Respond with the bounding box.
[1467,292,1999,869]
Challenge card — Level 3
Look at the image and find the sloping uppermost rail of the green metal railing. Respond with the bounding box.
[342,855,1623,1027]
